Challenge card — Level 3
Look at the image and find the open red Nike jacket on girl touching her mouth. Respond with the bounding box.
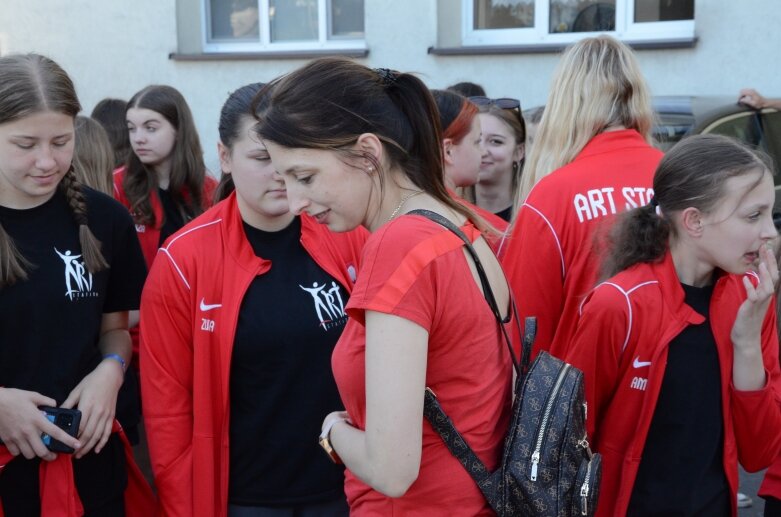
[566,252,781,517]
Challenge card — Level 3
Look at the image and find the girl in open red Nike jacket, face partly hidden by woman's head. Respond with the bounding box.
[141,84,366,517]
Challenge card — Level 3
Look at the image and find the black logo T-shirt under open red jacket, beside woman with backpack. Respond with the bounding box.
[229,217,347,506]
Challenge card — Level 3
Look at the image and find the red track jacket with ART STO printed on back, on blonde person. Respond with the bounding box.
[502,129,662,357]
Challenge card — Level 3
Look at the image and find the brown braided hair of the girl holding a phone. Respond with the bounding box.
[0,54,108,288]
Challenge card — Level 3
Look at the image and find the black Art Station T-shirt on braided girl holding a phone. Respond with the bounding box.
[0,187,146,506]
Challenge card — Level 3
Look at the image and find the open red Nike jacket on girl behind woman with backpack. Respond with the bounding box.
[141,193,368,517]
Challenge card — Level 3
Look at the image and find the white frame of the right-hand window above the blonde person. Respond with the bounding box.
[461,0,696,47]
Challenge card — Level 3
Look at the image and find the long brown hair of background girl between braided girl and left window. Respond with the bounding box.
[122,85,207,226]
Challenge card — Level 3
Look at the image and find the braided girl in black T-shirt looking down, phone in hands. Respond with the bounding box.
[0,54,153,517]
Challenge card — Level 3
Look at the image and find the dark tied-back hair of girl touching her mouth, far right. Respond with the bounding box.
[602,135,773,277]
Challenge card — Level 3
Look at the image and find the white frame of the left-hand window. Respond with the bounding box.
[199,0,367,54]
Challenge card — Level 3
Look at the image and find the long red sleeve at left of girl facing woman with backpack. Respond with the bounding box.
[141,254,194,516]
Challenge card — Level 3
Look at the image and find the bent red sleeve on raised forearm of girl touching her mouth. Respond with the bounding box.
[730,299,781,472]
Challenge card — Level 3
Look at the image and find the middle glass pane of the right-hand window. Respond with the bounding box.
[550,0,616,33]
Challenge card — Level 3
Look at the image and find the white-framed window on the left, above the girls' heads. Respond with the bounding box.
[202,0,365,52]
